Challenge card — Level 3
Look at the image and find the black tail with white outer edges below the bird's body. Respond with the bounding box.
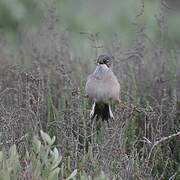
[90,102,114,122]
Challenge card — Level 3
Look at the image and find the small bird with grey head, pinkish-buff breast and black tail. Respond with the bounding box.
[85,54,120,122]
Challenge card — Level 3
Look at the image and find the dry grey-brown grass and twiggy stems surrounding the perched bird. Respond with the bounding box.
[0,6,180,179]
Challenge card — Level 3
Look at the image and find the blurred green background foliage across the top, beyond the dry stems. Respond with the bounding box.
[0,0,180,56]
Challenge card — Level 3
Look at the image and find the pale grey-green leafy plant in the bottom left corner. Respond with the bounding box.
[0,130,77,180]
